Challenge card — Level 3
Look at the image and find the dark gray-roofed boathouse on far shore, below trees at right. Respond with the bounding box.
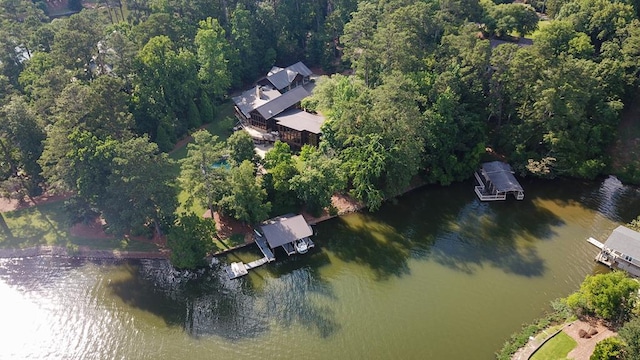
[474,161,524,201]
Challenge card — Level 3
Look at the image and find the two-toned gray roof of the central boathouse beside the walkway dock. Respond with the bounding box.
[260,215,313,249]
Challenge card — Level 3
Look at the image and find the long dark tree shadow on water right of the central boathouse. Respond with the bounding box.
[319,183,563,280]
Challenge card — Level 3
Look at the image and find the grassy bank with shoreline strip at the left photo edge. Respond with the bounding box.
[0,200,158,251]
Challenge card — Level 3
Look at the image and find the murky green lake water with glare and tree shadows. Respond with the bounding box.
[0,180,640,360]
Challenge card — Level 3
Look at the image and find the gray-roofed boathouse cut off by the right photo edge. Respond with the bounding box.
[589,226,640,277]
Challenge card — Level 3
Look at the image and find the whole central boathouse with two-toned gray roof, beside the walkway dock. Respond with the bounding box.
[260,215,315,255]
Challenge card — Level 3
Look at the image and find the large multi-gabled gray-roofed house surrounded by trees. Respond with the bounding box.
[233,62,324,148]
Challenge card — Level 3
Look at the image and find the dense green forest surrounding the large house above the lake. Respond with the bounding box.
[0,0,640,242]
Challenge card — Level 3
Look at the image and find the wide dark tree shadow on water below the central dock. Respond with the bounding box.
[109,255,340,341]
